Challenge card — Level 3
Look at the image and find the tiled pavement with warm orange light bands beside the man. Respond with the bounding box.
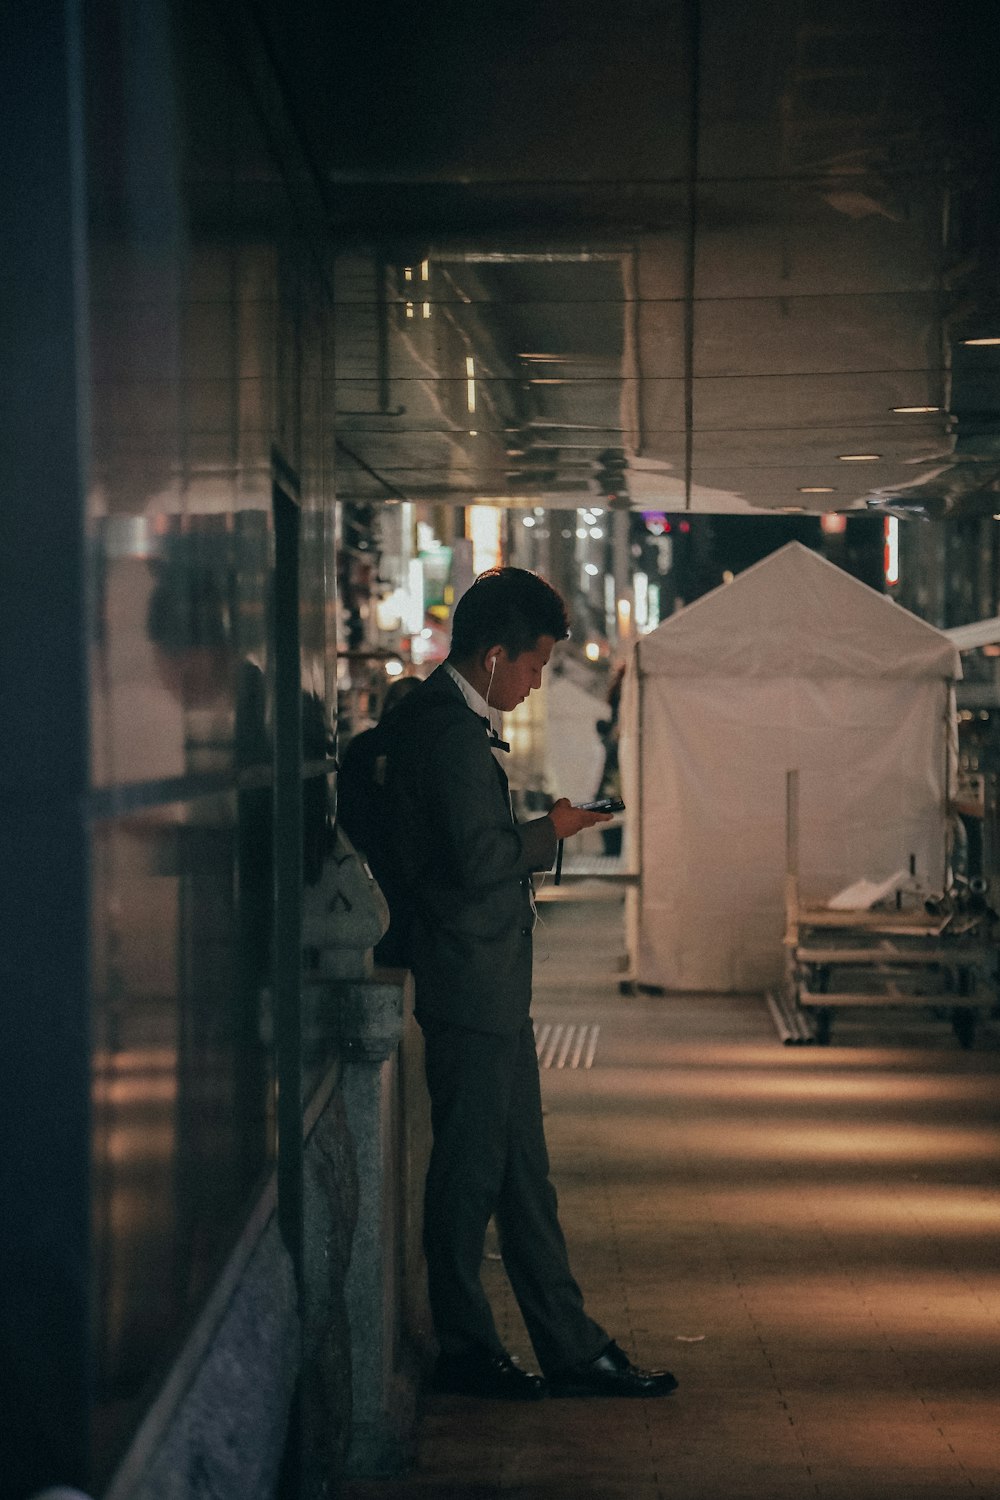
[345,887,1000,1500]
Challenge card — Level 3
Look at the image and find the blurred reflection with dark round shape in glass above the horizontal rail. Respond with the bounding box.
[93,510,271,786]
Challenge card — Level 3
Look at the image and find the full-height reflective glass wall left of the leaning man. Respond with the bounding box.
[85,0,336,1475]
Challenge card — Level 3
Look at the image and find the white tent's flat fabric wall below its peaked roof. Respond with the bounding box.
[630,678,949,990]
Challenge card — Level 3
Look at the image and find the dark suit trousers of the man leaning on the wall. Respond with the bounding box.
[423,1020,609,1374]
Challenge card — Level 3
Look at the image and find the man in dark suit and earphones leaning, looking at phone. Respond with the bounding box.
[376,569,676,1400]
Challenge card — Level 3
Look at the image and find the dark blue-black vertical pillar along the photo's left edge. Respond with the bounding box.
[0,0,94,1500]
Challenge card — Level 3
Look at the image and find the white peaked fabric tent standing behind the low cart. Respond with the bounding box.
[622,542,961,990]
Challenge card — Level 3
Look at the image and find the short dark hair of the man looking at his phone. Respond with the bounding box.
[451,567,570,662]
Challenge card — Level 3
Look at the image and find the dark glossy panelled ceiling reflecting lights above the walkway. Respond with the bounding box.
[260,0,1000,516]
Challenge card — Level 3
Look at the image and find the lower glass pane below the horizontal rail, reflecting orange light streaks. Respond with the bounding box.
[93,789,274,1470]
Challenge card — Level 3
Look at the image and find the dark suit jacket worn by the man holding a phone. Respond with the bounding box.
[385,668,556,1035]
